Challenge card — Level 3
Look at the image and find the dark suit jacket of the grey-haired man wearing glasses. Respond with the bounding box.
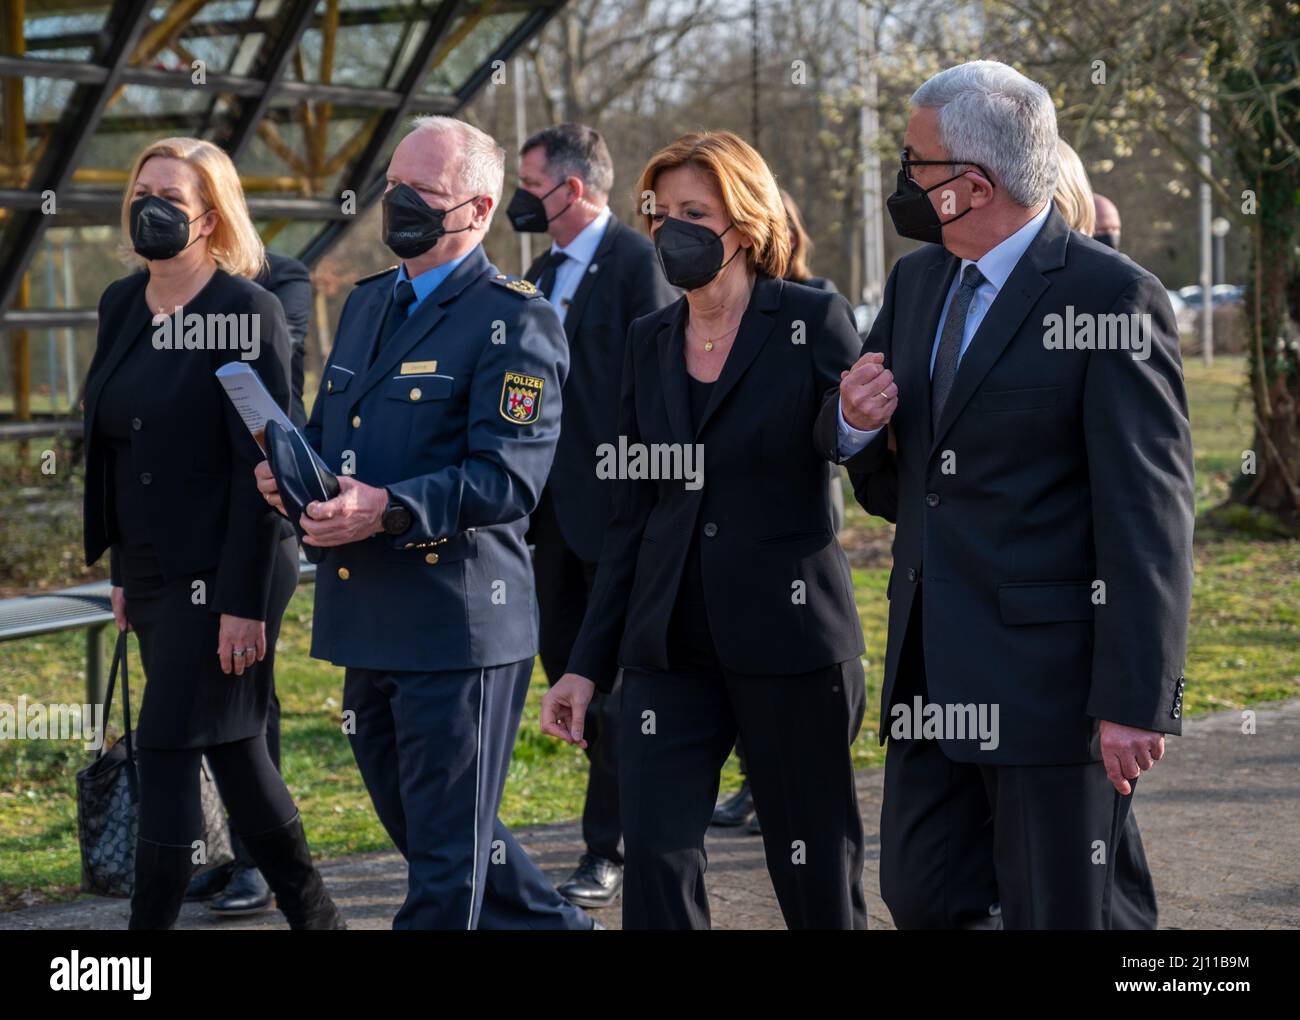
[818,210,1193,764]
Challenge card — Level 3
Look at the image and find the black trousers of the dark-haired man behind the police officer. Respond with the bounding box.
[532,498,623,863]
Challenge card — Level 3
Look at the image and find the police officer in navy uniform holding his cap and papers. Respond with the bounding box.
[259,117,593,929]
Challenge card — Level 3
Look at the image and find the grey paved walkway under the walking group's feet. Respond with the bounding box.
[0,699,1300,929]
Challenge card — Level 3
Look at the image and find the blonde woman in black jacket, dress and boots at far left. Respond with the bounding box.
[85,138,345,928]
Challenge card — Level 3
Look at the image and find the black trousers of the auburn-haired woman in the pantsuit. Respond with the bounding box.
[620,659,867,929]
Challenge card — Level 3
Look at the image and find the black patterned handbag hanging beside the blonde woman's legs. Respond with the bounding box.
[77,630,234,898]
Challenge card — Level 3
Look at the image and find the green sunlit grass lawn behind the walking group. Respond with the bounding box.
[0,357,1300,910]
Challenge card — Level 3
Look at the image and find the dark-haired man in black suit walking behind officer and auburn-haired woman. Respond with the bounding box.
[507,123,677,907]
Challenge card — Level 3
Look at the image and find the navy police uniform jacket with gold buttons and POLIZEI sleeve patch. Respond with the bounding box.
[306,247,568,672]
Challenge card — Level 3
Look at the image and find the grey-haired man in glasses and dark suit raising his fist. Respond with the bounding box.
[818,61,1193,928]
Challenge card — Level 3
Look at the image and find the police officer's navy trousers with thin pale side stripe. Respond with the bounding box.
[343,660,592,929]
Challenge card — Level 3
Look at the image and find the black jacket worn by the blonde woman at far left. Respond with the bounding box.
[85,269,289,620]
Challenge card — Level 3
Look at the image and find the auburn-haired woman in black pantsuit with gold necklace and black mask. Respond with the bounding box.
[542,131,866,928]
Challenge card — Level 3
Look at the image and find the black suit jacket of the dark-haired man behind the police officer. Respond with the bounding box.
[525,217,679,563]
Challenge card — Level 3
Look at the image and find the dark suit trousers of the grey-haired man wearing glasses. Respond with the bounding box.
[880,591,1156,929]
